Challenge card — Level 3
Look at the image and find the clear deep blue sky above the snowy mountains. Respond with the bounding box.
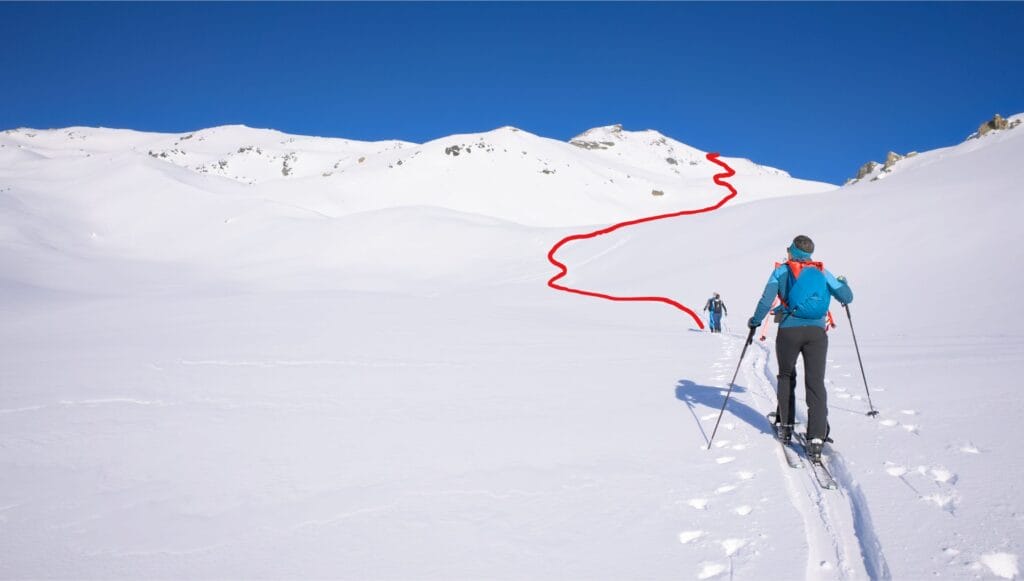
[0,3,1024,182]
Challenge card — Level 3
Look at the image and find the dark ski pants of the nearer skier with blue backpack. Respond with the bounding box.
[775,327,828,440]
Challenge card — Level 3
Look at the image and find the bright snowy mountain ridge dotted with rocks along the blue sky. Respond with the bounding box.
[0,125,836,225]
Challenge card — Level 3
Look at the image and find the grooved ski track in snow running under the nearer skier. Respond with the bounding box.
[739,332,892,579]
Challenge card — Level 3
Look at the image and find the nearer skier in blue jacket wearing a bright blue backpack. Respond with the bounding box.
[748,236,853,461]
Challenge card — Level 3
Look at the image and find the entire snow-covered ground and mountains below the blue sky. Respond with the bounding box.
[0,114,1024,579]
